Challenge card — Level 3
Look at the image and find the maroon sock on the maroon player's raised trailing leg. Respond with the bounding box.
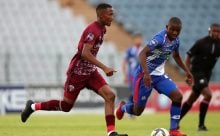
[35,100,73,112]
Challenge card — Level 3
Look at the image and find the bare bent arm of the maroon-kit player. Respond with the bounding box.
[82,44,116,76]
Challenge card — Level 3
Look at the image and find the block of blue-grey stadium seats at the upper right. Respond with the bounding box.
[88,0,220,81]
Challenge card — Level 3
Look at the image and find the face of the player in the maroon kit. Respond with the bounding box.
[100,8,114,26]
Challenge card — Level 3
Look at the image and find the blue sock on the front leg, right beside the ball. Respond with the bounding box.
[170,102,181,130]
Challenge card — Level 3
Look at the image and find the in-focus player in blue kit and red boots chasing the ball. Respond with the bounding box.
[116,17,193,136]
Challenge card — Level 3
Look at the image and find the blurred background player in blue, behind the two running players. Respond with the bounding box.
[122,33,143,105]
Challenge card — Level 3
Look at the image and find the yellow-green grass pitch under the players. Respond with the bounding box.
[0,112,220,136]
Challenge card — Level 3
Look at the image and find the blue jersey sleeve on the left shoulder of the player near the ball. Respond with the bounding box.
[146,35,163,50]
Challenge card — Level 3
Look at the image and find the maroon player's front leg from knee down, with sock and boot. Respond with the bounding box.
[98,85,127,136]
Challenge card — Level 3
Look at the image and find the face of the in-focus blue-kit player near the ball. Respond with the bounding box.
[167,24,182,40]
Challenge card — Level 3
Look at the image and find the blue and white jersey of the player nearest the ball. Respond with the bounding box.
[139,30,179,75]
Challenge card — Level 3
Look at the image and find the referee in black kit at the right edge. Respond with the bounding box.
[180,23,220,131]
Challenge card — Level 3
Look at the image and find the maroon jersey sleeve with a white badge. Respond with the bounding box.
[84,28,98,45]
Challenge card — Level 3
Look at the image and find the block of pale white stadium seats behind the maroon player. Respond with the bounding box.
[0,0,119,84]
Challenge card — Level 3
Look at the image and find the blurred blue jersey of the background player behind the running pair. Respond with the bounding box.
[125,45,142,76]
